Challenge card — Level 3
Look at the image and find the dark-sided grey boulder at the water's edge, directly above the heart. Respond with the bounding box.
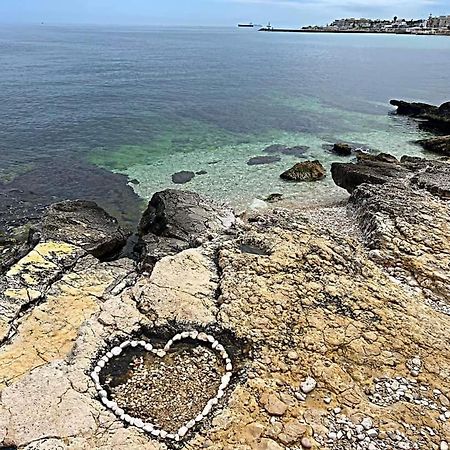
[139,189,234,267]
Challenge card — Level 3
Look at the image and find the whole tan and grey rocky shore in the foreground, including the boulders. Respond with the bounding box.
[0,145,450,450]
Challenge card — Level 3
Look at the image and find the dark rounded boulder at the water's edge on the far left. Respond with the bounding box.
[41,200,129,259]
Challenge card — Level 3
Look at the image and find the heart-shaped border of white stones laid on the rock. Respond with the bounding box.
[91,331,233,441]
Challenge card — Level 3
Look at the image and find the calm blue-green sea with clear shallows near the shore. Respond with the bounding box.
[0,24,450,224]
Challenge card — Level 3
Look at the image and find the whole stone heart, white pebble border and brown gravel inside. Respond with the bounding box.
[91,331,233,441]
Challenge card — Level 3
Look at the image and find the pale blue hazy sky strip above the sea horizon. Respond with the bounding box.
[0,0,450,26]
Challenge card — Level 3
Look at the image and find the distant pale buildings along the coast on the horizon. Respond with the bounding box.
[302,15,450,35]
